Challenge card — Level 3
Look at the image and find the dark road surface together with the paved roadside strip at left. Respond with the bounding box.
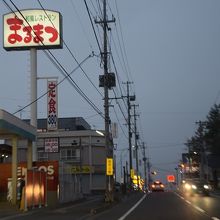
[3,192,220,220]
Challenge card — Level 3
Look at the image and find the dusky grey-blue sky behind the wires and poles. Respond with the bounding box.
[0,0,220,182]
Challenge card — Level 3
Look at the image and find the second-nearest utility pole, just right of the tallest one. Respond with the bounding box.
[124,81,135,189]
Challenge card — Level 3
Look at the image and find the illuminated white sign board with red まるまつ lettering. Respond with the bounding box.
[3,10,62,50]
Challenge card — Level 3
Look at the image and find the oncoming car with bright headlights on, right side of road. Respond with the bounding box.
[182,179,211,196]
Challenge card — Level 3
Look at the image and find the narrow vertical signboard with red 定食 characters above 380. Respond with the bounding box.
[47,80,58,131]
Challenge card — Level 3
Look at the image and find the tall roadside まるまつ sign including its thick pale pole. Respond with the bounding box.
[3,9,62,205]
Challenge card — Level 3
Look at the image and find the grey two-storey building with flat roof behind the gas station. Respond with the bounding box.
[1,117,106,204]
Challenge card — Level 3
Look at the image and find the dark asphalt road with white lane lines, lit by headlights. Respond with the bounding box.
[87,192,220,220]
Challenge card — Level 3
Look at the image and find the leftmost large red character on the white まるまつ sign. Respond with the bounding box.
[7,17,23,44]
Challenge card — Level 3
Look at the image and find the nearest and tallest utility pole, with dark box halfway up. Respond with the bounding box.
[95,0,115,202]
